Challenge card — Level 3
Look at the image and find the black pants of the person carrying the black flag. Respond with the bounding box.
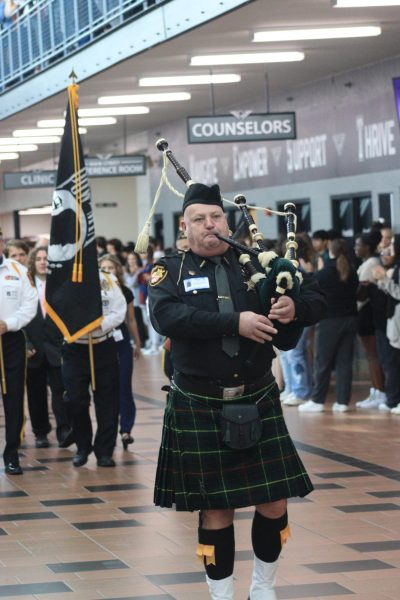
[62,338,119,458]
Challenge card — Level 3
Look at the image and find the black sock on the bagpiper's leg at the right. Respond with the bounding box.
[251,511,288,562]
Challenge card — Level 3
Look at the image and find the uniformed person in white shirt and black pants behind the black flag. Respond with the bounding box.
[62,271,126,467]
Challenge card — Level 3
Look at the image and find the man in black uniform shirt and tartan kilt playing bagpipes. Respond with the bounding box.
[149,184,326,600]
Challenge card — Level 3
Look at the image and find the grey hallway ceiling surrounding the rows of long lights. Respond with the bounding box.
[0,0,400,176]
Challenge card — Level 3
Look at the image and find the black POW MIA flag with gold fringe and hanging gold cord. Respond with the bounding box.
[45,84,103,343]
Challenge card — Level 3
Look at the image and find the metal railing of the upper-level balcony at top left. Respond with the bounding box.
[0,0,171,94]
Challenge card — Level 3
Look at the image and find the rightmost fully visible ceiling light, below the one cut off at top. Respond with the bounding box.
[253,25,382,42]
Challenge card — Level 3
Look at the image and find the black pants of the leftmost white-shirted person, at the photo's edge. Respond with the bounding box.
[1,331,26,464]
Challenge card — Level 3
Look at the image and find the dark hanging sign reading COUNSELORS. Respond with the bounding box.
[187,112,296,144]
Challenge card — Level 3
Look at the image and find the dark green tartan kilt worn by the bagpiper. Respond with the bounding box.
[154,382,313,511]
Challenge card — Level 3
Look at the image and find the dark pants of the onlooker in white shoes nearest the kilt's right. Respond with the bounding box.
[312,317,357,404]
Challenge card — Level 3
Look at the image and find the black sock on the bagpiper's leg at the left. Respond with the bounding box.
[198,525,235,579]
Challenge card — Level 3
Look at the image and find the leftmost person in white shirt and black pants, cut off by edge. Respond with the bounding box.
[0,231,38,475]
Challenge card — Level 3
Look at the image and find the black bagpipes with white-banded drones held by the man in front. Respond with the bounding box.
[138,139,303,350]
